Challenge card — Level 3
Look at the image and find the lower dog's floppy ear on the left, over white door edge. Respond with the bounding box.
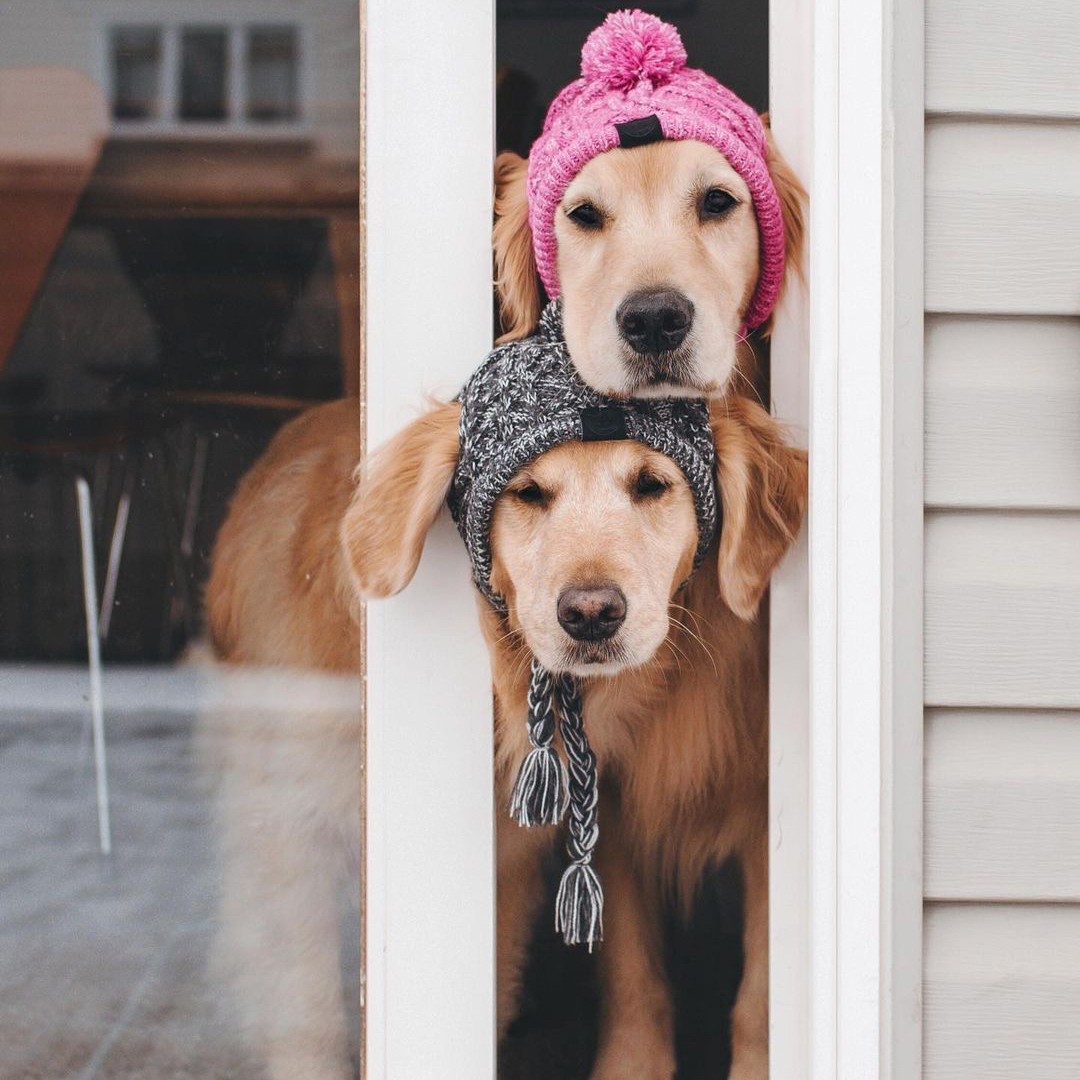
[341,402,461,599]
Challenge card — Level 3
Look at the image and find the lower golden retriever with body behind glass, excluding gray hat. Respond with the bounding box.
[207,384,806,1080]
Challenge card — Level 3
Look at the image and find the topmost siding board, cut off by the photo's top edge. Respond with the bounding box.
[927,0,1080,119]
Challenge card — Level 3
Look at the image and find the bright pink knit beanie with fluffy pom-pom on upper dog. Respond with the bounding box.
[528,11,784,329]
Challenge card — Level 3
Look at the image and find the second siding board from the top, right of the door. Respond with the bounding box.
[926,123,1080,315]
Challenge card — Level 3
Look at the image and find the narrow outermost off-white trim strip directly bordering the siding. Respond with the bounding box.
[881,0,926,1080]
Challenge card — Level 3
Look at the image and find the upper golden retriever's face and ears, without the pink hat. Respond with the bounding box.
[495,117,806,397]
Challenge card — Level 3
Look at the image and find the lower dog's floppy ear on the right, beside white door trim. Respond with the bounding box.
[711,397,807,621]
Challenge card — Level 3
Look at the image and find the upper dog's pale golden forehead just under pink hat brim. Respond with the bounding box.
[563,139,750,204]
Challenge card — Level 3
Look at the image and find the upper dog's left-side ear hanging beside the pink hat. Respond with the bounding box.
[491,150,540,345]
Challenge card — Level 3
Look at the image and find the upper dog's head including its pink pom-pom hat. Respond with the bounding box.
[495,11,805,397]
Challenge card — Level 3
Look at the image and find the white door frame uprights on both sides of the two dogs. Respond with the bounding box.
[365,0,922,1080]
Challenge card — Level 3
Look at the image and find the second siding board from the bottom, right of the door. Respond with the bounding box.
[924,710,1080,902]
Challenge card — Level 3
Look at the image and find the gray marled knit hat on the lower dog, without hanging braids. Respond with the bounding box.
[448,300,718,611]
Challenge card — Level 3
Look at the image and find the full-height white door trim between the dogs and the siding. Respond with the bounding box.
[771,0,923,1080]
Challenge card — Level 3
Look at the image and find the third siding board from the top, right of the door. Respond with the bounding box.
[926,315,1080,510]
